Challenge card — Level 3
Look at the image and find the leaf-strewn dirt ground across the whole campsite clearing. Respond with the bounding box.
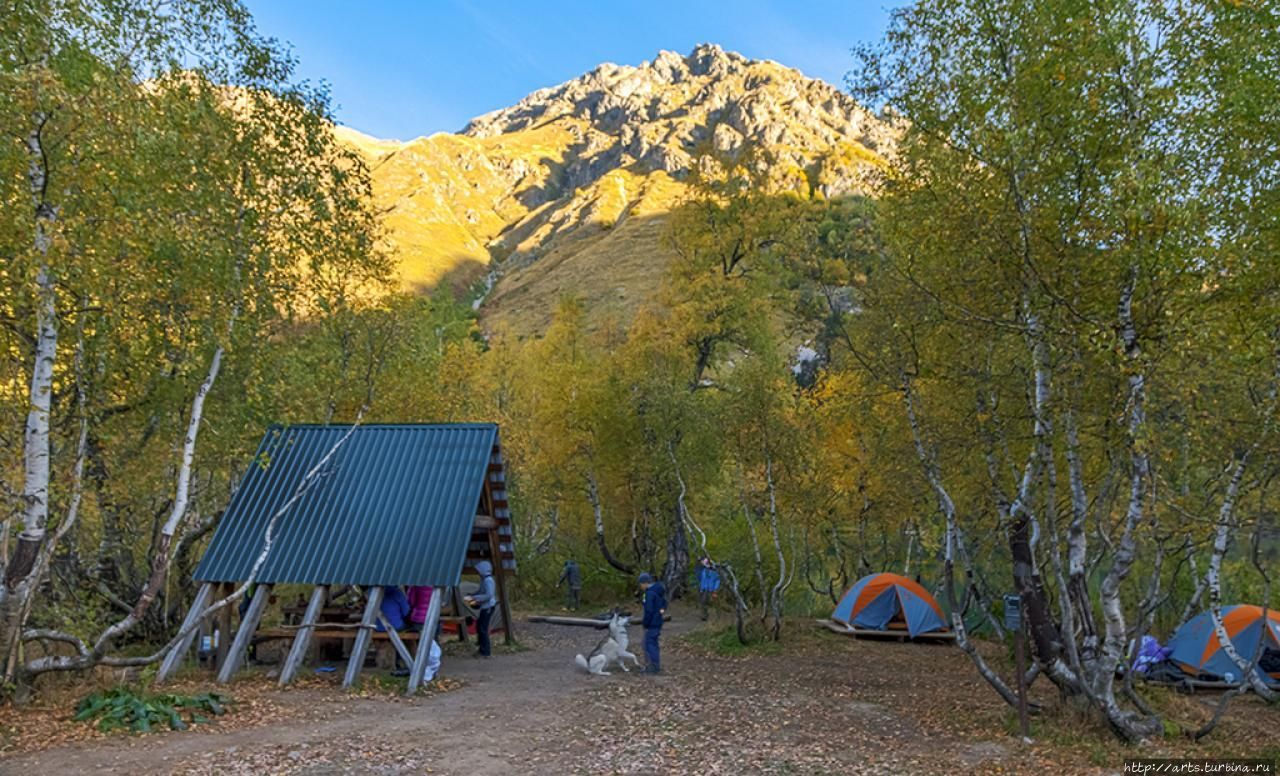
[0,611,1280,776]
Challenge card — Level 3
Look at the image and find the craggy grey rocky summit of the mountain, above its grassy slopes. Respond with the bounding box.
[463,44,892,196]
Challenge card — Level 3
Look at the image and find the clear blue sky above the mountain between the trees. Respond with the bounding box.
[246,0,893,140]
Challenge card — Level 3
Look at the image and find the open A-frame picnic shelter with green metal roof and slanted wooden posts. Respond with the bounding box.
[156,424,516,691]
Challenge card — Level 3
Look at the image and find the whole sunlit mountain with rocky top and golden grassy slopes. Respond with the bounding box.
[352,45,896,333]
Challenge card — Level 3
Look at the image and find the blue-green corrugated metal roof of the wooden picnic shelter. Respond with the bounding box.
[195,424,500,585]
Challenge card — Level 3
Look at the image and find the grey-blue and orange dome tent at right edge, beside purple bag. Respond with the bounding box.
[1166,604,1280,683]
